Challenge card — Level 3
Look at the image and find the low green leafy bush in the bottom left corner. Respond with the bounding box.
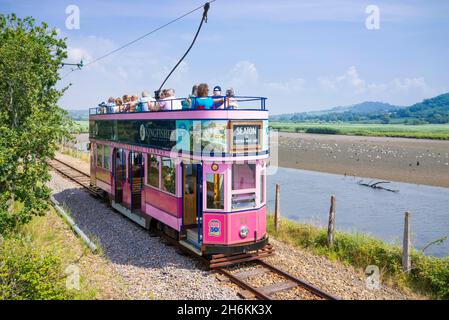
[0,236,71,300]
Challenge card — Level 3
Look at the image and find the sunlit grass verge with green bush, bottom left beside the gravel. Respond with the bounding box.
[0,210,124,300]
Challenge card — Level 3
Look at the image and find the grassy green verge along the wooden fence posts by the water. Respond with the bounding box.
[267,215,449,299]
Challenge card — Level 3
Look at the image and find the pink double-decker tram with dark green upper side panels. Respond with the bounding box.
[89,97,269,256]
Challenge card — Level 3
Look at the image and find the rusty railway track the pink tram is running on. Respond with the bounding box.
[48,159,338,300]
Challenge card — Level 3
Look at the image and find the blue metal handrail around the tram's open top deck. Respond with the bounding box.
[89,96,267,115]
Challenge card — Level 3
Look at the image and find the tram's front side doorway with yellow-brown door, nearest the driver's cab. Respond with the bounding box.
[183,164,202,228]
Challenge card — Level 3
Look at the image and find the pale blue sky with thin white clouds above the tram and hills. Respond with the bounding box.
[0,0,449,114]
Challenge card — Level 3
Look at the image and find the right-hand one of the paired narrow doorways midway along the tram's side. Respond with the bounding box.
[128,151,144,210]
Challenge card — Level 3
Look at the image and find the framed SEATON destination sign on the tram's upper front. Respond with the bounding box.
[231,121,263,151]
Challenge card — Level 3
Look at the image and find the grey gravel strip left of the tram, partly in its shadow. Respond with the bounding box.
[49,173,239,300]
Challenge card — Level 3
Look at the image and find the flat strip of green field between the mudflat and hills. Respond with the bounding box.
[270,122,449,140]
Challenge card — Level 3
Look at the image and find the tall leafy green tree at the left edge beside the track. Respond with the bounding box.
[0,14,68,234]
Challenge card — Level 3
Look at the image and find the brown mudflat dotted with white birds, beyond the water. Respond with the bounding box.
[278,132,449,187]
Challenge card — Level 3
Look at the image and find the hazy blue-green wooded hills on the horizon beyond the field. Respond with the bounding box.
[270,93,449,124]
